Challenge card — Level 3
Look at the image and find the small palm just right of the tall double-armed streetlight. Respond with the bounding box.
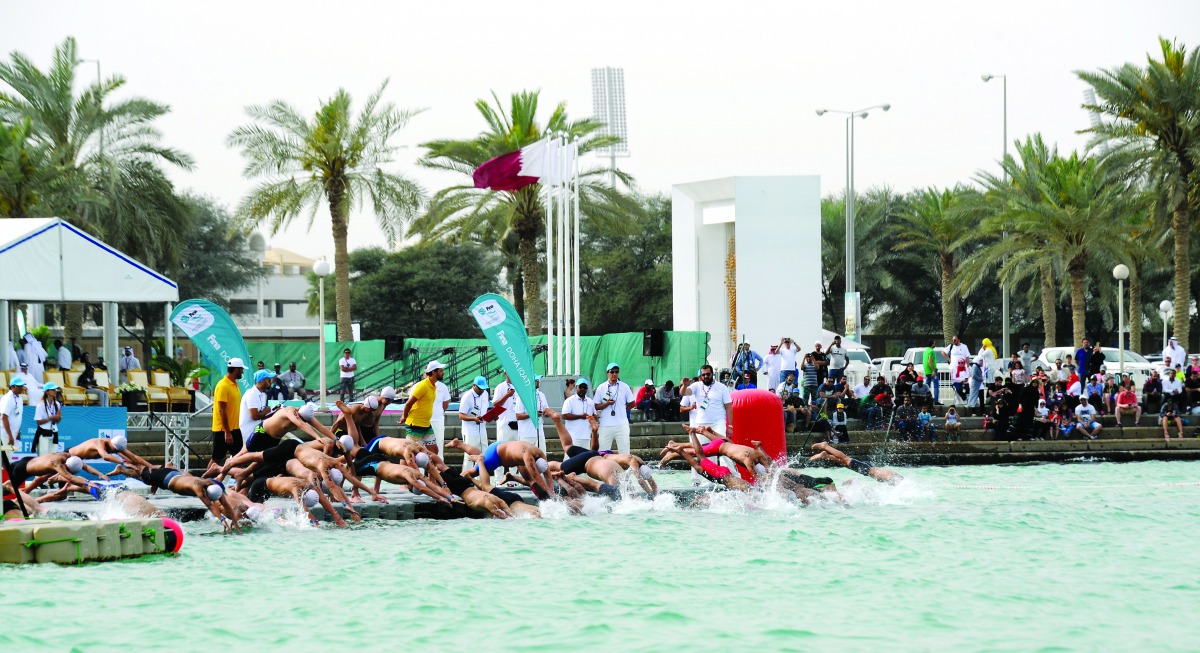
[894,187,974,342]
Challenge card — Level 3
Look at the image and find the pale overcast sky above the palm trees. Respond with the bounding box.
[0,0,1200,257]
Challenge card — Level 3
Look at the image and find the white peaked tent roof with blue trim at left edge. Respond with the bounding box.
[0,217,179,304]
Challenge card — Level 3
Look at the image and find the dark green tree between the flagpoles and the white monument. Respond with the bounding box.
[580,196,673,335]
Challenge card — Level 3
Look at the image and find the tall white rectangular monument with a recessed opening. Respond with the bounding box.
[671,175,820,370]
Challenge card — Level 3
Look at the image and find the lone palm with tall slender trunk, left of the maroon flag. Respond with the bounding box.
[227,80,424,341]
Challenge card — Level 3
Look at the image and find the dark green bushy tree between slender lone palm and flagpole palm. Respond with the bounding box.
[350,241,500,339]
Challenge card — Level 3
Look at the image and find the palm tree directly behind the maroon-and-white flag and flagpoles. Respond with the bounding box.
[409,91,642,333]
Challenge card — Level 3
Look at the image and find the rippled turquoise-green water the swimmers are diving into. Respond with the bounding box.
[0,462,1200,652]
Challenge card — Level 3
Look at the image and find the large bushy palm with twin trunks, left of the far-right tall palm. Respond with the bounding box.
[960,134,1141,346]
